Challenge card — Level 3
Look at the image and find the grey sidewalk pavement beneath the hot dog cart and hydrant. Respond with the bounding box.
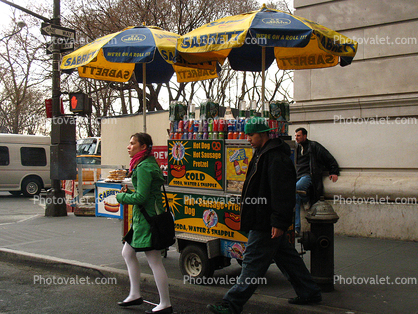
[0,213,418,313]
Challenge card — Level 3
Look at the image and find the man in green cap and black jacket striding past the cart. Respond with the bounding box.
[207,118,322,314]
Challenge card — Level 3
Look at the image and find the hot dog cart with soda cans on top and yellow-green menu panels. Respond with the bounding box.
[96,100,294,278]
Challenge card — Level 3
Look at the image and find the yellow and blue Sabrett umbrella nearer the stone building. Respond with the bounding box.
[176,5,357,101]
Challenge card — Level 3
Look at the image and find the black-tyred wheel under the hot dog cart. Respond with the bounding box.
[179,245,215,278]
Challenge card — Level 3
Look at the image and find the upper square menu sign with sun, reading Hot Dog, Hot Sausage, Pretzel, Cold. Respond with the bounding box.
[168,140,224,190]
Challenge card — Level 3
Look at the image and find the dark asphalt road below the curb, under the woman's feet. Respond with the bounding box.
[0,262,229,314]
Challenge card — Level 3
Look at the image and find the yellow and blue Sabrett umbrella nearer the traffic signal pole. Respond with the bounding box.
[61,26,217,131]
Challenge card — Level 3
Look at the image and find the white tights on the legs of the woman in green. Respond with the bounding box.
[122,242,171,311]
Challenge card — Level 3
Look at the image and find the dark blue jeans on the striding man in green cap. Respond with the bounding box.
[223,230,321,314]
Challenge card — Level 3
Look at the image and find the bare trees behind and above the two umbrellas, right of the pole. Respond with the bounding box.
[58,0,289,136]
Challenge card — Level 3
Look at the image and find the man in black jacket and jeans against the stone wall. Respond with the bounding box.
[295,128,340,234]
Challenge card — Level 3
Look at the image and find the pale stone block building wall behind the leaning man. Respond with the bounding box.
[290,0,418,240]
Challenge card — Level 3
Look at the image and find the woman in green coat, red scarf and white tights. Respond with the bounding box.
[116,133,173,314]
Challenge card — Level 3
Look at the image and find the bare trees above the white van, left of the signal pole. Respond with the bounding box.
[0,19,50,134]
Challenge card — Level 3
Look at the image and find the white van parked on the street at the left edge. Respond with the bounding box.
[0,133,51,196]
